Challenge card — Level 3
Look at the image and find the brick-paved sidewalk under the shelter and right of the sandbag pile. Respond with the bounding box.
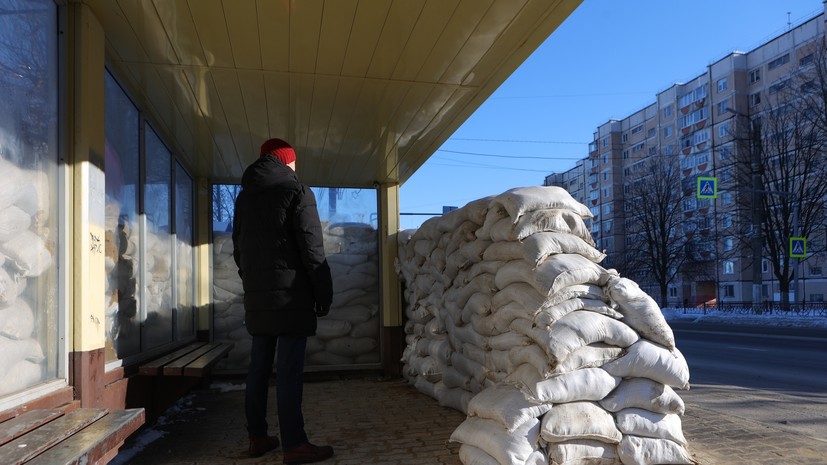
[111,377,827,465]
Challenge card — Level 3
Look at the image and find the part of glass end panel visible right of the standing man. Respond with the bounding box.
[307,187,381,366]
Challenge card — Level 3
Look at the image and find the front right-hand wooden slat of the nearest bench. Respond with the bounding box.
[26,408,144,465]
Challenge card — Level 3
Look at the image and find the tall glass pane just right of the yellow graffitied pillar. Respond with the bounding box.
[104,71,141,362]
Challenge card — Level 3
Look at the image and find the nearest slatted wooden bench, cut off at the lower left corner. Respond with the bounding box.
[0,408,145,465]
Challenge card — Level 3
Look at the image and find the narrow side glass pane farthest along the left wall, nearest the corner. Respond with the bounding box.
[175,163,195,339]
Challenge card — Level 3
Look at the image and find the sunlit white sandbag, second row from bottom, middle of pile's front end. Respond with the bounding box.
[540,402,621,444]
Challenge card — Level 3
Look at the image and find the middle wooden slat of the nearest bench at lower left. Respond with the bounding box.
[0,408,106,465]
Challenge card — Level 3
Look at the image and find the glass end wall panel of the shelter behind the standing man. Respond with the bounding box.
[213,185,381,371]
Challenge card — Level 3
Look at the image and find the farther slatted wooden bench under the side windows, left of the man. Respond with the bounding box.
[139,342,234,376]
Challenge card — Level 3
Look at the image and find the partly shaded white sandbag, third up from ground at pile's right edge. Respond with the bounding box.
[600,378,686,415]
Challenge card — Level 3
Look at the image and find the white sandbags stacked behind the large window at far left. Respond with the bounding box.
[0,158,50,395]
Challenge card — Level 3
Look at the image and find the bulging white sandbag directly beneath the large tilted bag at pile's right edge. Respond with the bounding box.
[603,339,689,389]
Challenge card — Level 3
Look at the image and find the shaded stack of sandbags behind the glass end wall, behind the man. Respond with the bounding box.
[213,223,380,371]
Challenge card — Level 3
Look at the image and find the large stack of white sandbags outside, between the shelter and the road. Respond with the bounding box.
[397,187,692,464]
